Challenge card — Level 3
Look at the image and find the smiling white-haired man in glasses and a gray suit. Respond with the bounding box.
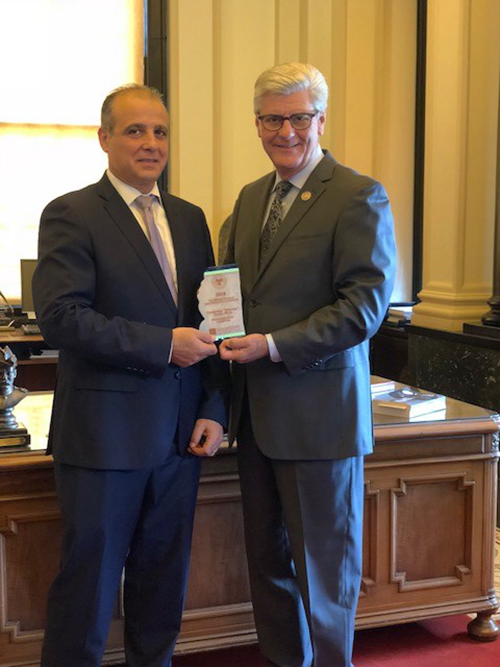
[220,63,396,667]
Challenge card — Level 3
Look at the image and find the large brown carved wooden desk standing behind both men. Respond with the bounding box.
[0,393,499,667]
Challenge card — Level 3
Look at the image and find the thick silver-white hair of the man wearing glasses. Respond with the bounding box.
[253,62,328,113]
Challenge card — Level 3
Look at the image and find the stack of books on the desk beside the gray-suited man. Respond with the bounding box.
[372,387,446,419]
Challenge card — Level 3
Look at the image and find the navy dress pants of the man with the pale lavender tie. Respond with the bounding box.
[41,450,200,667]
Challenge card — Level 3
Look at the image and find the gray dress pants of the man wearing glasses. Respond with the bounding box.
[238,414,364,667]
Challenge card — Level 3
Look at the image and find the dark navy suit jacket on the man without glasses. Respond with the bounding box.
[33,176,225,469]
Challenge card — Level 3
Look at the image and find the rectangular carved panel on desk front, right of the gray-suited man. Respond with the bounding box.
[391,473,474,591]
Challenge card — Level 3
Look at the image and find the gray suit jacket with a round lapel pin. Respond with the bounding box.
[226,153,396,460]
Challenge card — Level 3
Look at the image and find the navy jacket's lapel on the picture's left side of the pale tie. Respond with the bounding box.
[97,175,177,315]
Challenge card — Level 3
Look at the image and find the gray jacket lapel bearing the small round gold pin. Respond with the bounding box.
[257,152,336,279]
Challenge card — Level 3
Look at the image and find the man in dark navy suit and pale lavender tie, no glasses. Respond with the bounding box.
[33,85,225,667]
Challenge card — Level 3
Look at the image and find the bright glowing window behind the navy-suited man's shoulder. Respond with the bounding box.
[0,0,144,304]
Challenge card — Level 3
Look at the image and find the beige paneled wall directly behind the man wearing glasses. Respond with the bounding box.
[169,0,416,300]
